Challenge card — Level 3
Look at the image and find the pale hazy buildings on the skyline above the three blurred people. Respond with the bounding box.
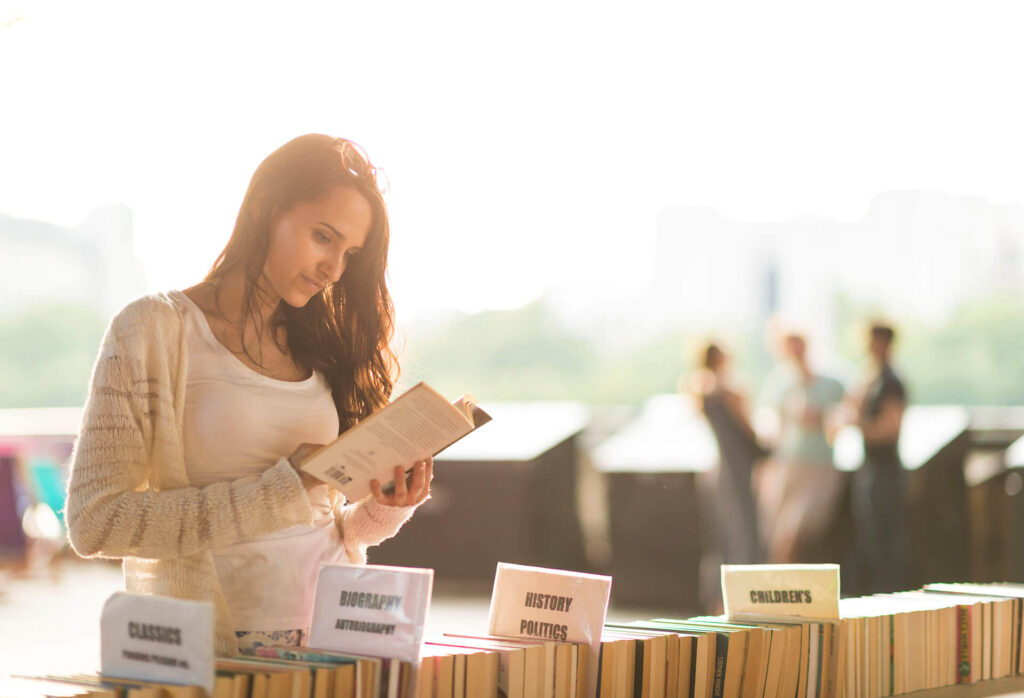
[653,191,1024,338]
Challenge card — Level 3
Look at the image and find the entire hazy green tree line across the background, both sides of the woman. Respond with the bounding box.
[0,296,1024,407]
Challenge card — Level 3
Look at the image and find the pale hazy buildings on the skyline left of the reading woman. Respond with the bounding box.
[0,205,145,316]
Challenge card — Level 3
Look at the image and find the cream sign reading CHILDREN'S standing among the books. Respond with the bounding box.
[722,565,839,620]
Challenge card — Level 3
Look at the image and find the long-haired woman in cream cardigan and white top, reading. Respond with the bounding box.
[67,134,432,655]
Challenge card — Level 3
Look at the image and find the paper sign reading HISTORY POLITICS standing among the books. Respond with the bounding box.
[487,562,611,698]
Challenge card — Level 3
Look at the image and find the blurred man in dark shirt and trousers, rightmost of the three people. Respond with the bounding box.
[851,323,908,593]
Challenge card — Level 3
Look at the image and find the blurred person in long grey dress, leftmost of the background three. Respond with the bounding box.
[688,343,767,565]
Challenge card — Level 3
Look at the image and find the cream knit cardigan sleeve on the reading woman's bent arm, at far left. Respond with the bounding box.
[67,306,312,558]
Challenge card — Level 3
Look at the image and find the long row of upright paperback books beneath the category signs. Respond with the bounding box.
[18,584,1024,698]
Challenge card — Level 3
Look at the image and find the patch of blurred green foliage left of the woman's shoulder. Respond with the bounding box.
[0,303,105,407]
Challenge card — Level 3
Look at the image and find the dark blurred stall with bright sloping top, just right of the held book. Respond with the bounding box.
[370,402,589,586]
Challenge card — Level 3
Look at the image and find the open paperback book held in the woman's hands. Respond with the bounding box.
[300,383,490,501]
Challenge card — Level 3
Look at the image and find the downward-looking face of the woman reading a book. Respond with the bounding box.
[263,186,374,308]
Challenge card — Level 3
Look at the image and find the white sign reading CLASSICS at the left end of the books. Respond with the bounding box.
[99,592,215,695]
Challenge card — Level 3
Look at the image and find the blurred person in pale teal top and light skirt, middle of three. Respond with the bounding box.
[758,333,845,563]
